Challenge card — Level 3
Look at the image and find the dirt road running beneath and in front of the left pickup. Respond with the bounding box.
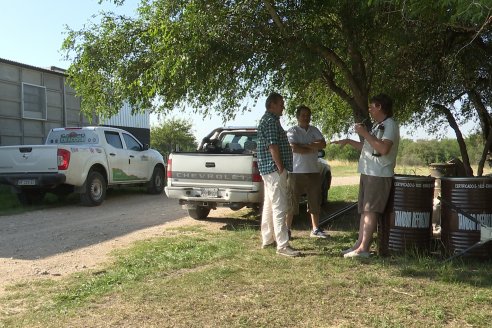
[0,177,359,297]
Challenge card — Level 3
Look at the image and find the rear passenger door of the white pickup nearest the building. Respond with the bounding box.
[104,131,132,182]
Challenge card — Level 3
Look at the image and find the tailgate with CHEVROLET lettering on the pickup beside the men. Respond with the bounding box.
[171,153,255,189]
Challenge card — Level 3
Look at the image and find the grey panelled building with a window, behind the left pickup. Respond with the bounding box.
[0,58,150,146]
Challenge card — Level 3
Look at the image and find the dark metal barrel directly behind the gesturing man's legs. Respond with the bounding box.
[379,175,435,255]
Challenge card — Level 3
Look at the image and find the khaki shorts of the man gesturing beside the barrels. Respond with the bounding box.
[358,174,393,214]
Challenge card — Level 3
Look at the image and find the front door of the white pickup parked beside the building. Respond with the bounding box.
[122,132,148,180]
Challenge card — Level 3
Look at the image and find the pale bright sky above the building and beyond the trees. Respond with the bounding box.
[0,0,476,141]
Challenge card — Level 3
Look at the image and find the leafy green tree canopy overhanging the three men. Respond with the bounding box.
[63,0,492,174]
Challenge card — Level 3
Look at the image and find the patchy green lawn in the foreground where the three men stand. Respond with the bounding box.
[0,186,492,327]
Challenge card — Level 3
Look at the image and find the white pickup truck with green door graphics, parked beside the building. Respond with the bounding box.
[0,127,165,206]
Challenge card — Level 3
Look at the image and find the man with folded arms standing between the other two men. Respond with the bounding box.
[287,105,328,238]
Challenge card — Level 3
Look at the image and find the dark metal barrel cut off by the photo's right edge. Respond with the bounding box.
[441,177,492,258]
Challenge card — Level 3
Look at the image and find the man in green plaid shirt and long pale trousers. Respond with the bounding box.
[257,92,300,257]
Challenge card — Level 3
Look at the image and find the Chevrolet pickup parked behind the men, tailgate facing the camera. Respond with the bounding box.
[165,127,331,220]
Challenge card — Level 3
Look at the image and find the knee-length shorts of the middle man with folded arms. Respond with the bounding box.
[289,172,321,215]
